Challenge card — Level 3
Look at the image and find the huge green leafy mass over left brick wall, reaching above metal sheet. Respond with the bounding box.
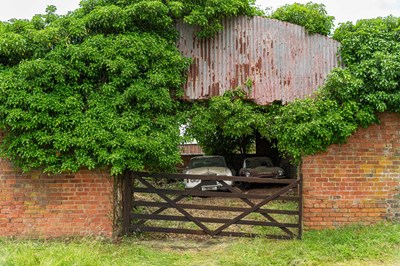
[0,0,258,175]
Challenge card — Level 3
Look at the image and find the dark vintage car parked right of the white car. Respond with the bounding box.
[239,157,285,178]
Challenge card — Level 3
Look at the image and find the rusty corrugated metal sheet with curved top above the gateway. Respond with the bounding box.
[177,17,339,104]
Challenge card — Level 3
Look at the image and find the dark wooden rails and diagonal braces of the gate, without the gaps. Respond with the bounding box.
[123,172,302,239]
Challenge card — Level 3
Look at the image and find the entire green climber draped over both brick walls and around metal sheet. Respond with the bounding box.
[0,0,400,172]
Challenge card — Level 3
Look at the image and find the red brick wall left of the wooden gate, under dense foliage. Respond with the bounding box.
[0,156,113,238]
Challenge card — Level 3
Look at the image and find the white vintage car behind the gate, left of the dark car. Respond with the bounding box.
[183,155,232,191]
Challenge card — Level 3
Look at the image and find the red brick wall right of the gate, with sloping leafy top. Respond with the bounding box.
[302,113,400,229]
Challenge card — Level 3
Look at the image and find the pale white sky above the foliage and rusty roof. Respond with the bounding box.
[0,0,400,23]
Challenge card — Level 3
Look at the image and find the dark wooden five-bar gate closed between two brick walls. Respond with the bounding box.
[123,172,302,239]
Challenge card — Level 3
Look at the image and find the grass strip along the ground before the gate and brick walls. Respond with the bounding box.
[0,223,400,266]
